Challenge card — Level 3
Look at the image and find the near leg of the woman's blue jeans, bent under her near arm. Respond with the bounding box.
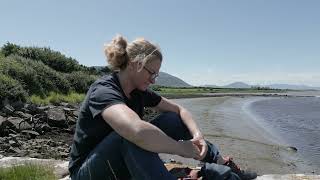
[71,132,175,180]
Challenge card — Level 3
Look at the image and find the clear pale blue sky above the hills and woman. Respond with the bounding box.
[0,0,320,87]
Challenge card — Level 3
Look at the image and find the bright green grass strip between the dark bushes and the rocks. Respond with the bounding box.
[29,92,85,105]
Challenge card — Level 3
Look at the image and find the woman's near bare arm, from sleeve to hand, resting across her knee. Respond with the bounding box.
[102,104,199,158]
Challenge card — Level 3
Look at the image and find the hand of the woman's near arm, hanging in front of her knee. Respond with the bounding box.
[178,140,200,159]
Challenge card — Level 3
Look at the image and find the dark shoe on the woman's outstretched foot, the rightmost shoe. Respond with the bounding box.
[224,157,258,180]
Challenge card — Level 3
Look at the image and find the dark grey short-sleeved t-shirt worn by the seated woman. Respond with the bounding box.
[69,73,161,172]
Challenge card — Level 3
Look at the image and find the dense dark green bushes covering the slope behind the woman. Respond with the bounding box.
[0,43,110,103]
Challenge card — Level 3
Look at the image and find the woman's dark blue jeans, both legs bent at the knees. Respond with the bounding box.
[71,112,224,180]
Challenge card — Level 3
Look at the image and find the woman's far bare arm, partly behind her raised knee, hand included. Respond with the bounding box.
[155,97,208,160]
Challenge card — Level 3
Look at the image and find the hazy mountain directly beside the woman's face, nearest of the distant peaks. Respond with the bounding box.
[155,72,191,87]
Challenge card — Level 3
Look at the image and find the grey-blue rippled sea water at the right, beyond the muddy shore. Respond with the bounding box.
[248,97,320,169]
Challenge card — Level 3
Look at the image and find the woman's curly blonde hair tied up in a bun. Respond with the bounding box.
[104,35,162,71]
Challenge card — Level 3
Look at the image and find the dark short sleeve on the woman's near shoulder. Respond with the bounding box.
[89,85,125,118]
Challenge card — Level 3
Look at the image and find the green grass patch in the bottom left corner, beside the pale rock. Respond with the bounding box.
[0,164,57,180]
